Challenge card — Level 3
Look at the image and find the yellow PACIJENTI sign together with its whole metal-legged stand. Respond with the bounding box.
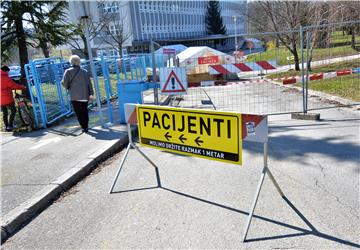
[109,104,286,242]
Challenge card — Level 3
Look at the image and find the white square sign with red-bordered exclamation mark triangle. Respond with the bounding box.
[160,68,187,94]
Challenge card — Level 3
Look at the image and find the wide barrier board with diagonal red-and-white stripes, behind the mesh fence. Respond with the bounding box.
[209,61,276,75]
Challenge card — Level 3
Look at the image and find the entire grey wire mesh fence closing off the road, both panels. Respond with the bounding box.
[160,21,360,114]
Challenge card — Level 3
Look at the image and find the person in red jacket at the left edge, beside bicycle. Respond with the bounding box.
[0,65,26,132]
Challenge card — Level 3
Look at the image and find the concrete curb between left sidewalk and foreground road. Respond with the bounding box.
[1,128,132,244]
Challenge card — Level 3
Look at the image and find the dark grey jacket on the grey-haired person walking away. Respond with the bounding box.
[61,66,94,101]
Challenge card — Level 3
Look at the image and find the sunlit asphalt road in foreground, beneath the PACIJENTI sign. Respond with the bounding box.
[3,106,360,249]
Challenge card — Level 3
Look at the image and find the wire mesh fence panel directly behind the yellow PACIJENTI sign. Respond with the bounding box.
[162,31,302,114]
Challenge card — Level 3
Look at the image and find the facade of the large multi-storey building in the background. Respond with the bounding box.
[70,0,247,52]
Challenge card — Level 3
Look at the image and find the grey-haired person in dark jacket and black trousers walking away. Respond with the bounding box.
[62,55,94,133]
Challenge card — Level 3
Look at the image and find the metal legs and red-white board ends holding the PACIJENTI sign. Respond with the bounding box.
[109,104,286,242]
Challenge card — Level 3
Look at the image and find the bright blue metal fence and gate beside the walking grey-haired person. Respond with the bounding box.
[25,54,168,128]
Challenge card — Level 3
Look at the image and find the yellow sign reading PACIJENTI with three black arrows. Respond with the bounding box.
[136,105,242,165]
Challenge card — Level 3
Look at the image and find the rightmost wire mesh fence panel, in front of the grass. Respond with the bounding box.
[301,20,360,112]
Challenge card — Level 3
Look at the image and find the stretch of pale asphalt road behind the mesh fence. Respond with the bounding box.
[178,81,316,114]
